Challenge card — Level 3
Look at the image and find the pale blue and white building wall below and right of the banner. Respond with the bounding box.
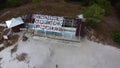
[28,19,76,38]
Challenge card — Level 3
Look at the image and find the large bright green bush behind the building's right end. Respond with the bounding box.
[83,4,105,28]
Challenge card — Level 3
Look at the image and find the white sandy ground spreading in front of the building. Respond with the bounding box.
[0,33,120,68]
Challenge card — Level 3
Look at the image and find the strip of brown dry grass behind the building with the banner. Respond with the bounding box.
[0,1,81,22]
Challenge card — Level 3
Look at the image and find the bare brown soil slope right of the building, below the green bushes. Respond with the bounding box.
[87,10,120,48]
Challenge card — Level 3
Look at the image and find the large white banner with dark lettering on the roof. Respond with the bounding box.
[33,14,64,32]
